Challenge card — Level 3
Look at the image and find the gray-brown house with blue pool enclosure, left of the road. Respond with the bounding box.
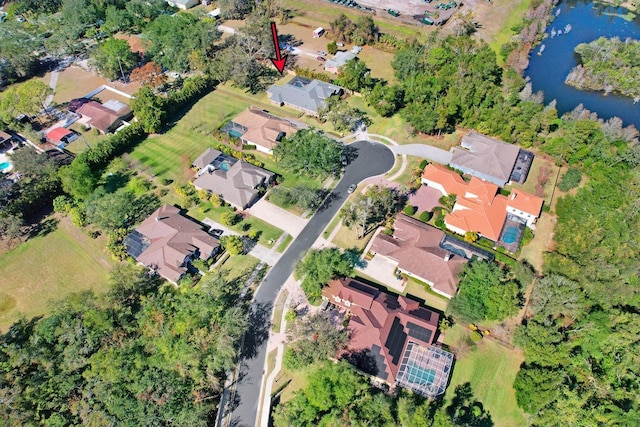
[193,153,274,209]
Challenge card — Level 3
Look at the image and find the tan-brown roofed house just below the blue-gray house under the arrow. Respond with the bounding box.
[233,107,297,150]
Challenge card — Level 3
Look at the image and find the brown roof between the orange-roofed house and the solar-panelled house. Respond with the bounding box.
[371,214,467,297]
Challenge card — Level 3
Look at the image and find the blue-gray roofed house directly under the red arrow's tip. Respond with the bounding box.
[267,76,344,116]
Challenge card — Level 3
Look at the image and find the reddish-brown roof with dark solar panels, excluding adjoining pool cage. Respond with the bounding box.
[322,278,440,383]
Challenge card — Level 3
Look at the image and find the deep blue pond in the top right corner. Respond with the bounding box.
[525,0,640,129]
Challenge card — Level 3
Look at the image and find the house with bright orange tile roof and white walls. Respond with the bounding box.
[422,164,544,246]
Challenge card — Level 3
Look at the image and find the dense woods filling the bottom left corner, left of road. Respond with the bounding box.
[0,266,245,426]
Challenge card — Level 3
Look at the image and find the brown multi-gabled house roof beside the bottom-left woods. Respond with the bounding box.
[130,205,219,282]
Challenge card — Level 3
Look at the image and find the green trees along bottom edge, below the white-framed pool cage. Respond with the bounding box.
[273,361,493,427]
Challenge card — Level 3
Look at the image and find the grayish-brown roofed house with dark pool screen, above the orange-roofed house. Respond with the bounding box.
[449,131,533,187]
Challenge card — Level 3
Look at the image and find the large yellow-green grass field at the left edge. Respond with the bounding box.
[0,219,111,331]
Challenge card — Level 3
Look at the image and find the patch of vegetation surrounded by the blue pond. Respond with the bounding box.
[565,37,640,102]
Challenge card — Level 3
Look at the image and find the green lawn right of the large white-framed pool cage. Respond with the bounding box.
[444,325,527,427]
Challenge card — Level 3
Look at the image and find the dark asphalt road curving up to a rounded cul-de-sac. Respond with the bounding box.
[230,141,394,427]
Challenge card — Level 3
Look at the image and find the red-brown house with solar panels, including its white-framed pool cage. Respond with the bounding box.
[322,278,453,398]
